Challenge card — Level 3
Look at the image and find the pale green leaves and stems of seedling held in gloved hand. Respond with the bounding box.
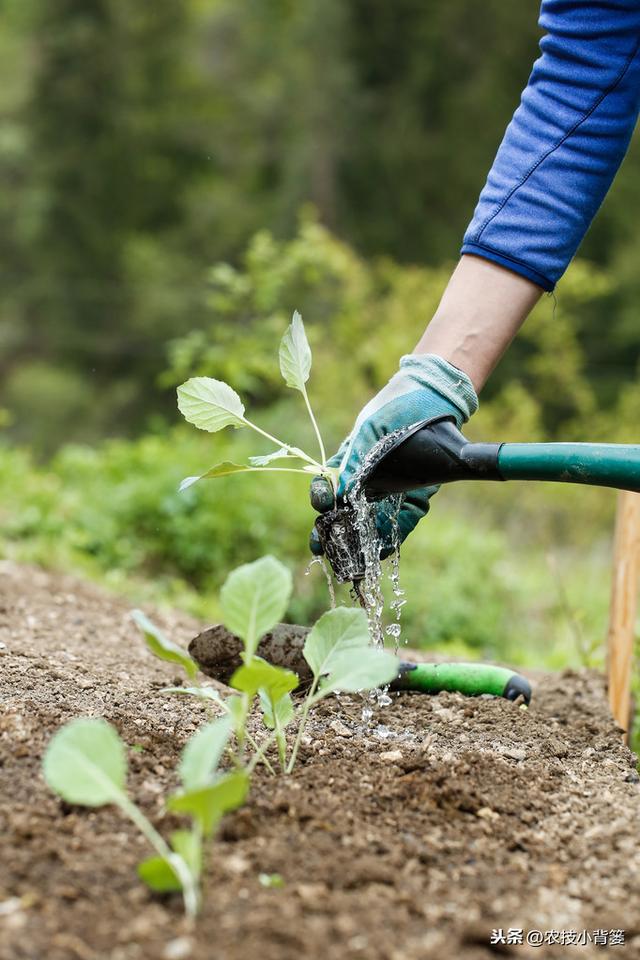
[178,311,338,490]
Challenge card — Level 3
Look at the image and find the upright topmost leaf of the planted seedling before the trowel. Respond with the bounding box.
[220,556,292,657]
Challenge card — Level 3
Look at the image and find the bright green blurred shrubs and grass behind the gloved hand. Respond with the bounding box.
[0,222,633,680]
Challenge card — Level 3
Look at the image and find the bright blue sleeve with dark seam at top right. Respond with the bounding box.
[462,0,640,290]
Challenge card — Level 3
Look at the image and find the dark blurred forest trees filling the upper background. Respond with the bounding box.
[0,0,640,456]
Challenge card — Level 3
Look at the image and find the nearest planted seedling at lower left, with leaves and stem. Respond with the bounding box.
[43,718,249,918]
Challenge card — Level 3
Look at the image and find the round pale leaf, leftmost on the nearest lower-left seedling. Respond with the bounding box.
[42,718,127,807]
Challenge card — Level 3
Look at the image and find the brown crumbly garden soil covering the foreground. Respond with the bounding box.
[0,564,640,960]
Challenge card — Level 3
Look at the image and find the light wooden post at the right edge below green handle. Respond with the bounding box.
[607,490,640,741]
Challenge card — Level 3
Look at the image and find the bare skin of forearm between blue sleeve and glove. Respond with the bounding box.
[415,255,543,393]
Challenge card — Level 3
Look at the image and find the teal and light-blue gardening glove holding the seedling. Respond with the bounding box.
[309,353,478,559]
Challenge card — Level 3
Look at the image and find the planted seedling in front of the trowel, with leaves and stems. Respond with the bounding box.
[136,556,398,773]
